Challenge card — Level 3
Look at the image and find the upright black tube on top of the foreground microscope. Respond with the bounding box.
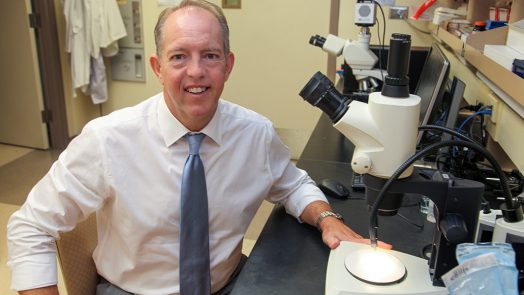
[382,33,411,98]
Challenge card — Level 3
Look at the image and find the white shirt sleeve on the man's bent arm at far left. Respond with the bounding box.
[7,124,107,290]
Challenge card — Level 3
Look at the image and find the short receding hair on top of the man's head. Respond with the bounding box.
[155,0,230,57]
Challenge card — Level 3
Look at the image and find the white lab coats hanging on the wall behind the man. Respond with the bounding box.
[62,0,127,103]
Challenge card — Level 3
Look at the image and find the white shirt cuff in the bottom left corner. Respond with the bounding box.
[9,254,57,291]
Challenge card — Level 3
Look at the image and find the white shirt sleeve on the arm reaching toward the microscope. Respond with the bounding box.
[267,127,328,222]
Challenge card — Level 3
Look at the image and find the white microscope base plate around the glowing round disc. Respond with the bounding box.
[325,242,448,295]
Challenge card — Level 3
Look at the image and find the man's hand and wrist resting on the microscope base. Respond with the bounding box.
[300,201,392,249]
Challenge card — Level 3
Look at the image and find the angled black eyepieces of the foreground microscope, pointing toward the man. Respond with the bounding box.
[299,72,348,123]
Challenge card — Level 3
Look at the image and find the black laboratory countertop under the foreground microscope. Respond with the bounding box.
[231,115,434,295]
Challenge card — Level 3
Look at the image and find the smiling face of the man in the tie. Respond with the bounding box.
[150,7,234,131]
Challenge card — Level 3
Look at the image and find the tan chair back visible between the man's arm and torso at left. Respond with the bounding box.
[56,214,98,295]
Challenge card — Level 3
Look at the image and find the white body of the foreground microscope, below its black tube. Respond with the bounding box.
[333,92,420,178]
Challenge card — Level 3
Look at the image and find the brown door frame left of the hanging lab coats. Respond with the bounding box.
[31,0,71,149]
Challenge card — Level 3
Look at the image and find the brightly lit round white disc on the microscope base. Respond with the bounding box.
[345,247,406,285]
